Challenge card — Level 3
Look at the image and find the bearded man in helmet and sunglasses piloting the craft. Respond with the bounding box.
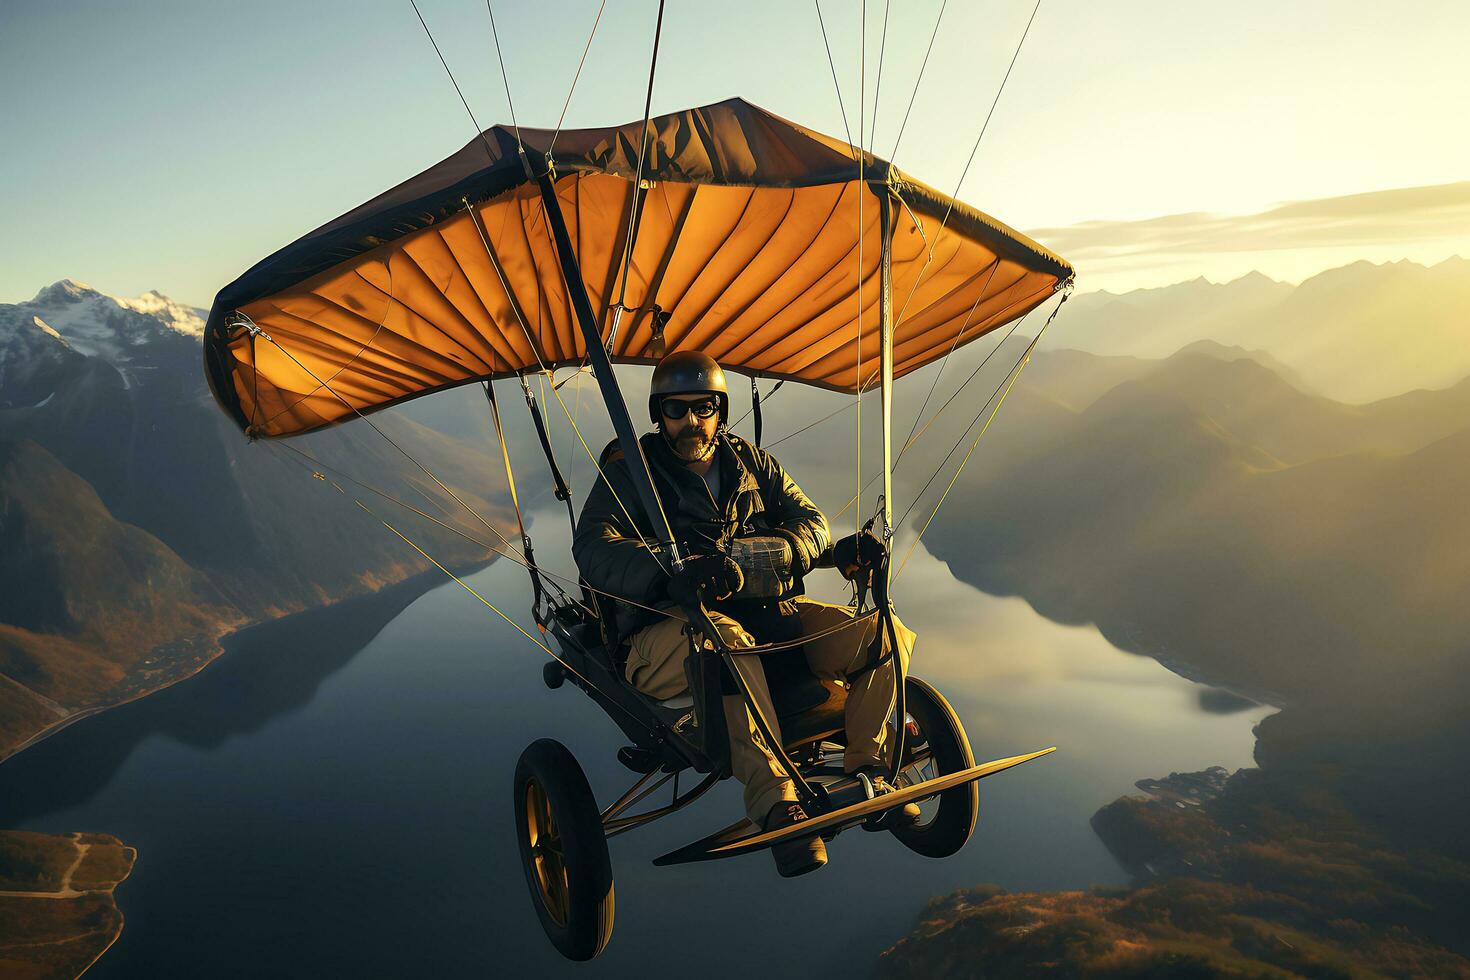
[572,351,919,877]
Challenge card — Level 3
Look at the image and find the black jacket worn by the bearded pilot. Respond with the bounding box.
[572,432,832,642]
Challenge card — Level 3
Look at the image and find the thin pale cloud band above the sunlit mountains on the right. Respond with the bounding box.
[1028,181,1470,264]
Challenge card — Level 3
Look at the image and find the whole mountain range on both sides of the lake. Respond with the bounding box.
[0,260,1470,976]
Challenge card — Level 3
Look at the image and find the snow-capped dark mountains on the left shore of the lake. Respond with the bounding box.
[0,279,512,758]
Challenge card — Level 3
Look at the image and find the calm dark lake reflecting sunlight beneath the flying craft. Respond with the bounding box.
[0,511,1270,979]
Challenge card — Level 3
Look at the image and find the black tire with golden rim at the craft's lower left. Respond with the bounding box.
[512,739,613,959]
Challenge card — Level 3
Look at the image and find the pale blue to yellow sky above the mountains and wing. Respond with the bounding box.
[0,0,1470,307]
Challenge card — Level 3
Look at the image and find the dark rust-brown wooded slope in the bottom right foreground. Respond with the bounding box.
[876,770,1470,980]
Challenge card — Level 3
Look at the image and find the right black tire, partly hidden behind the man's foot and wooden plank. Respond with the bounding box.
[892,677,980,858]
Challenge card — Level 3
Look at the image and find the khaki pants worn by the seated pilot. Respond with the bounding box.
[626,598,916,824]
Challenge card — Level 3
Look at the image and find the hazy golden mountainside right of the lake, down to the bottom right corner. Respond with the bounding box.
[876,334,1470,979]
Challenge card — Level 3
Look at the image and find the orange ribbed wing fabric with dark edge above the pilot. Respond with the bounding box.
[206,100,1072,436]
